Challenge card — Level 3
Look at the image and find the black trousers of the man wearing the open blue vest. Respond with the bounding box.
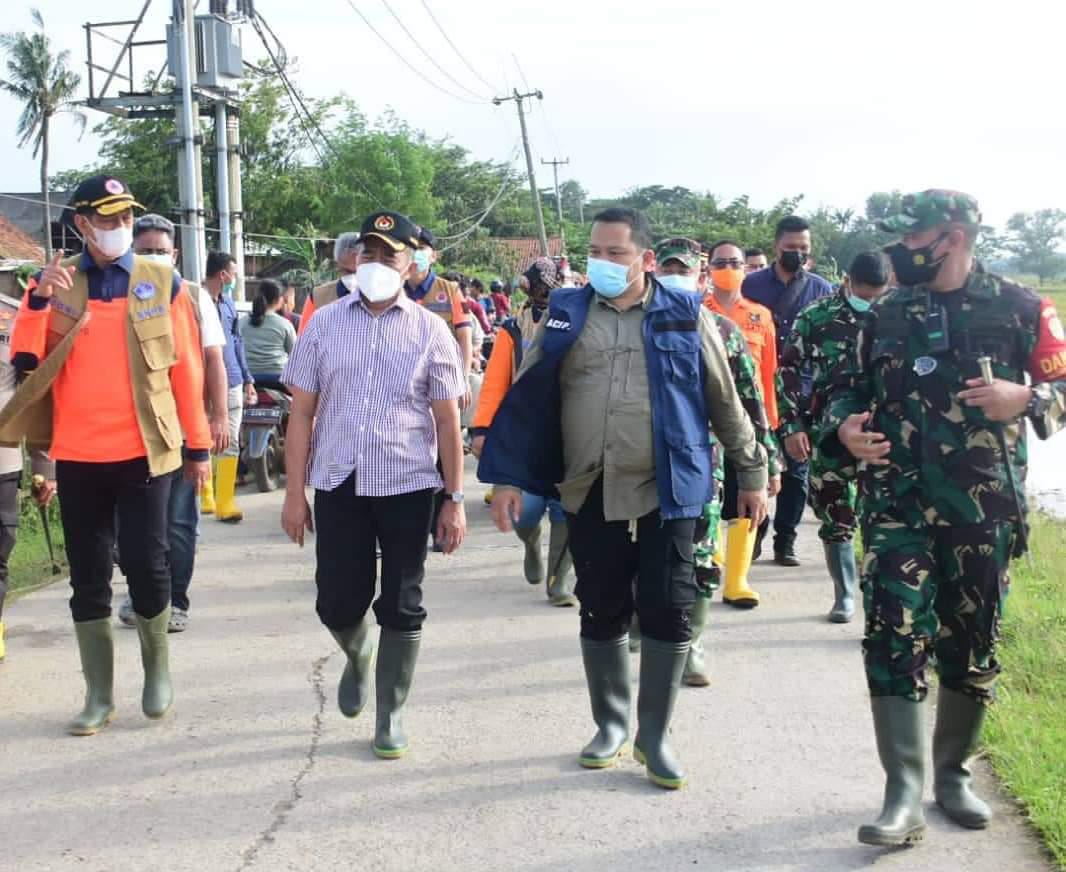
[566,478,697,642]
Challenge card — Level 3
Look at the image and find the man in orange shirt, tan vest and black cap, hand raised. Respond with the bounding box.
[6,176,211,736]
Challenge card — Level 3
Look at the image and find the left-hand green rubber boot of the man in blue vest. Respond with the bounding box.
[579,635,629,769]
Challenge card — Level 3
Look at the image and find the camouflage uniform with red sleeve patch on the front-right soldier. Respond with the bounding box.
[821,265,1066,703]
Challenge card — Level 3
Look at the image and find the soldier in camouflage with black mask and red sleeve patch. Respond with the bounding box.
[820,190,1066,845]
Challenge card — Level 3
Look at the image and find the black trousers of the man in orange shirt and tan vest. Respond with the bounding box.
[55,457,172,623]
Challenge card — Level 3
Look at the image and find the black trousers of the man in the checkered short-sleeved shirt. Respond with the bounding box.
[314,474,433,630]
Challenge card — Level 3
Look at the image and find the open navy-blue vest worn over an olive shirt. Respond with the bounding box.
[478,282,713,520]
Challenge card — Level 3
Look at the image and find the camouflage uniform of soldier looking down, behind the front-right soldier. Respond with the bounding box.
[777,290,861,543]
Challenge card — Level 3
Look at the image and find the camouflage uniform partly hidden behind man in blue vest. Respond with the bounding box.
[694,312,781,595]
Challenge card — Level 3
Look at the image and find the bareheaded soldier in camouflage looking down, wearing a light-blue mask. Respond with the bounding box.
[777,252,889,624]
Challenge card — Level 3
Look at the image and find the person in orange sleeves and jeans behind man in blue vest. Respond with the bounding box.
[470,257,577,607]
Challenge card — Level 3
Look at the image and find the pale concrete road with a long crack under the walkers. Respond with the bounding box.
[0,469,1051,872]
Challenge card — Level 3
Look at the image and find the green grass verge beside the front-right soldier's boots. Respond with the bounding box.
[985,515,1066,869]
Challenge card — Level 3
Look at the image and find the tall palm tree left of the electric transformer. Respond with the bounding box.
[0,10,86,259]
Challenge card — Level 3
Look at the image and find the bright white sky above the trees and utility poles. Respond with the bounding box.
[0,0,1066,234]
